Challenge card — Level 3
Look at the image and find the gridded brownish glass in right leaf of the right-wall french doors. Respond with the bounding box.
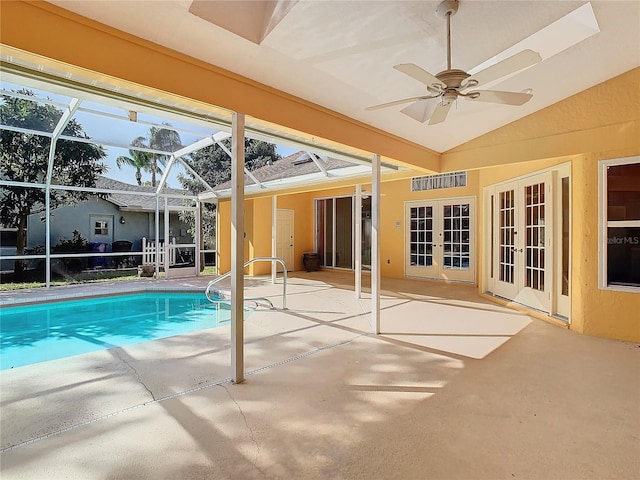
[524,183,545,291]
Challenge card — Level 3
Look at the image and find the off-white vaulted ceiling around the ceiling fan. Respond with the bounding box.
[37,0,640,152]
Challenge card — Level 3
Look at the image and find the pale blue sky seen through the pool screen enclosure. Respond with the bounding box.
[0,82,296,188]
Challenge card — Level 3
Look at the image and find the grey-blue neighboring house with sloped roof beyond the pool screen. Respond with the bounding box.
[27,176,193,255]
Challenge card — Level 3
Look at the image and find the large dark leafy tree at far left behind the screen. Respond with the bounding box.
[0,90,107,277]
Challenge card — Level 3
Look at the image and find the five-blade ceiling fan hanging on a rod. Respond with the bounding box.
[366,0,542,125]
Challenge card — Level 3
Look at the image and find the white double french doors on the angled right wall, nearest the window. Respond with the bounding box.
[492,172,553,312]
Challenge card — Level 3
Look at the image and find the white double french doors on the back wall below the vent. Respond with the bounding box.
[405,198,475,282]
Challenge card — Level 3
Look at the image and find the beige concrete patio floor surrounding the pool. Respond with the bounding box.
[0,272,640,479]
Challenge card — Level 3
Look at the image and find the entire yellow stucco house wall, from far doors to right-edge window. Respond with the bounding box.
[216,69,640,341]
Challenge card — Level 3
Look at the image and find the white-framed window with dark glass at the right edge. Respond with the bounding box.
[599,157,640,290]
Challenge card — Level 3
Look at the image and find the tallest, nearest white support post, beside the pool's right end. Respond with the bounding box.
[231,112,244,383]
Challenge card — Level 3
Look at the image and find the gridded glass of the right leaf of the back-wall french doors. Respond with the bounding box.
[442,203,470,270]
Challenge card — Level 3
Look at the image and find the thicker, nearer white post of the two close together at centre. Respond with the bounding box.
[371,155,380,335]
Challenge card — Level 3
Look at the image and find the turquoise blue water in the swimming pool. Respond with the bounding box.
[0,292,231,370]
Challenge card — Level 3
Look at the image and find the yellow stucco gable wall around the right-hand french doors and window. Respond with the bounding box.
[458,68,640,341]
